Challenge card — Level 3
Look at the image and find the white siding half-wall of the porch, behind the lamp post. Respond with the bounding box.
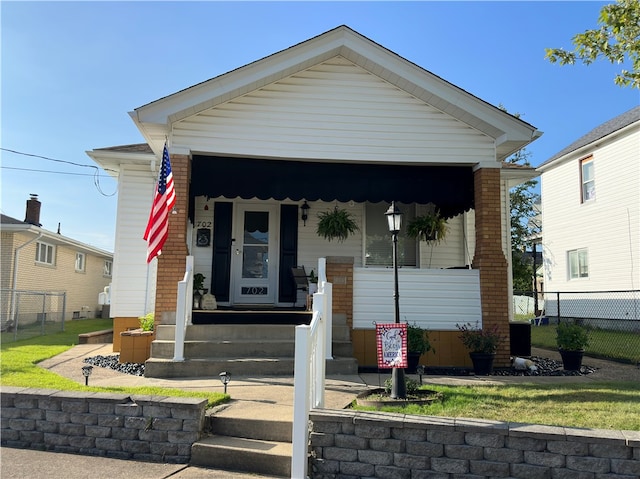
[353,268,482,331]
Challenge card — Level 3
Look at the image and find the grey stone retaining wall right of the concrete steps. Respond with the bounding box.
[309,410,640,479]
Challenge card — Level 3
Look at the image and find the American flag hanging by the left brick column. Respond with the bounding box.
[144,143,176,263]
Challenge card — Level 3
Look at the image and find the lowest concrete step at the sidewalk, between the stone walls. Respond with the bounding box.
[190,435,292,477]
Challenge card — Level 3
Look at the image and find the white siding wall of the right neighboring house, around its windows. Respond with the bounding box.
[541,126,640,291]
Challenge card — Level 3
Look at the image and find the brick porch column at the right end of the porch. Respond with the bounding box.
[473,168,510,367]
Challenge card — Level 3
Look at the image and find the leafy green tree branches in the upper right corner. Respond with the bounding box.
[545,0,640,89]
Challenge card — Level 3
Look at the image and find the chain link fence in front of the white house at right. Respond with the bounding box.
[513,290,640,364]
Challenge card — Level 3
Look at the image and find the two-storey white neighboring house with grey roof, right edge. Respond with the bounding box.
[537,106,640,326]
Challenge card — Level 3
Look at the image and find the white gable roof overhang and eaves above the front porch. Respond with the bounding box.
[129,25,541,160]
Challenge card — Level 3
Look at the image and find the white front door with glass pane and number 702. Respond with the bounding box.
[232,204,278,304]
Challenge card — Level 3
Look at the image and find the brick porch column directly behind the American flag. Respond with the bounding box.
[155,155,191,324]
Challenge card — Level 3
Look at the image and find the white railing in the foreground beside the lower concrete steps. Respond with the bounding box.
[291,258,332,479]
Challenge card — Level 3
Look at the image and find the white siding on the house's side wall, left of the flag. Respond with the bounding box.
[111,166,157,317]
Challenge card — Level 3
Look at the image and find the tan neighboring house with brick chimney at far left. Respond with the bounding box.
[0,195,113,329]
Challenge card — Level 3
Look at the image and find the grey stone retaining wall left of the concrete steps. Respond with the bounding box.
[0,386,207,463]
